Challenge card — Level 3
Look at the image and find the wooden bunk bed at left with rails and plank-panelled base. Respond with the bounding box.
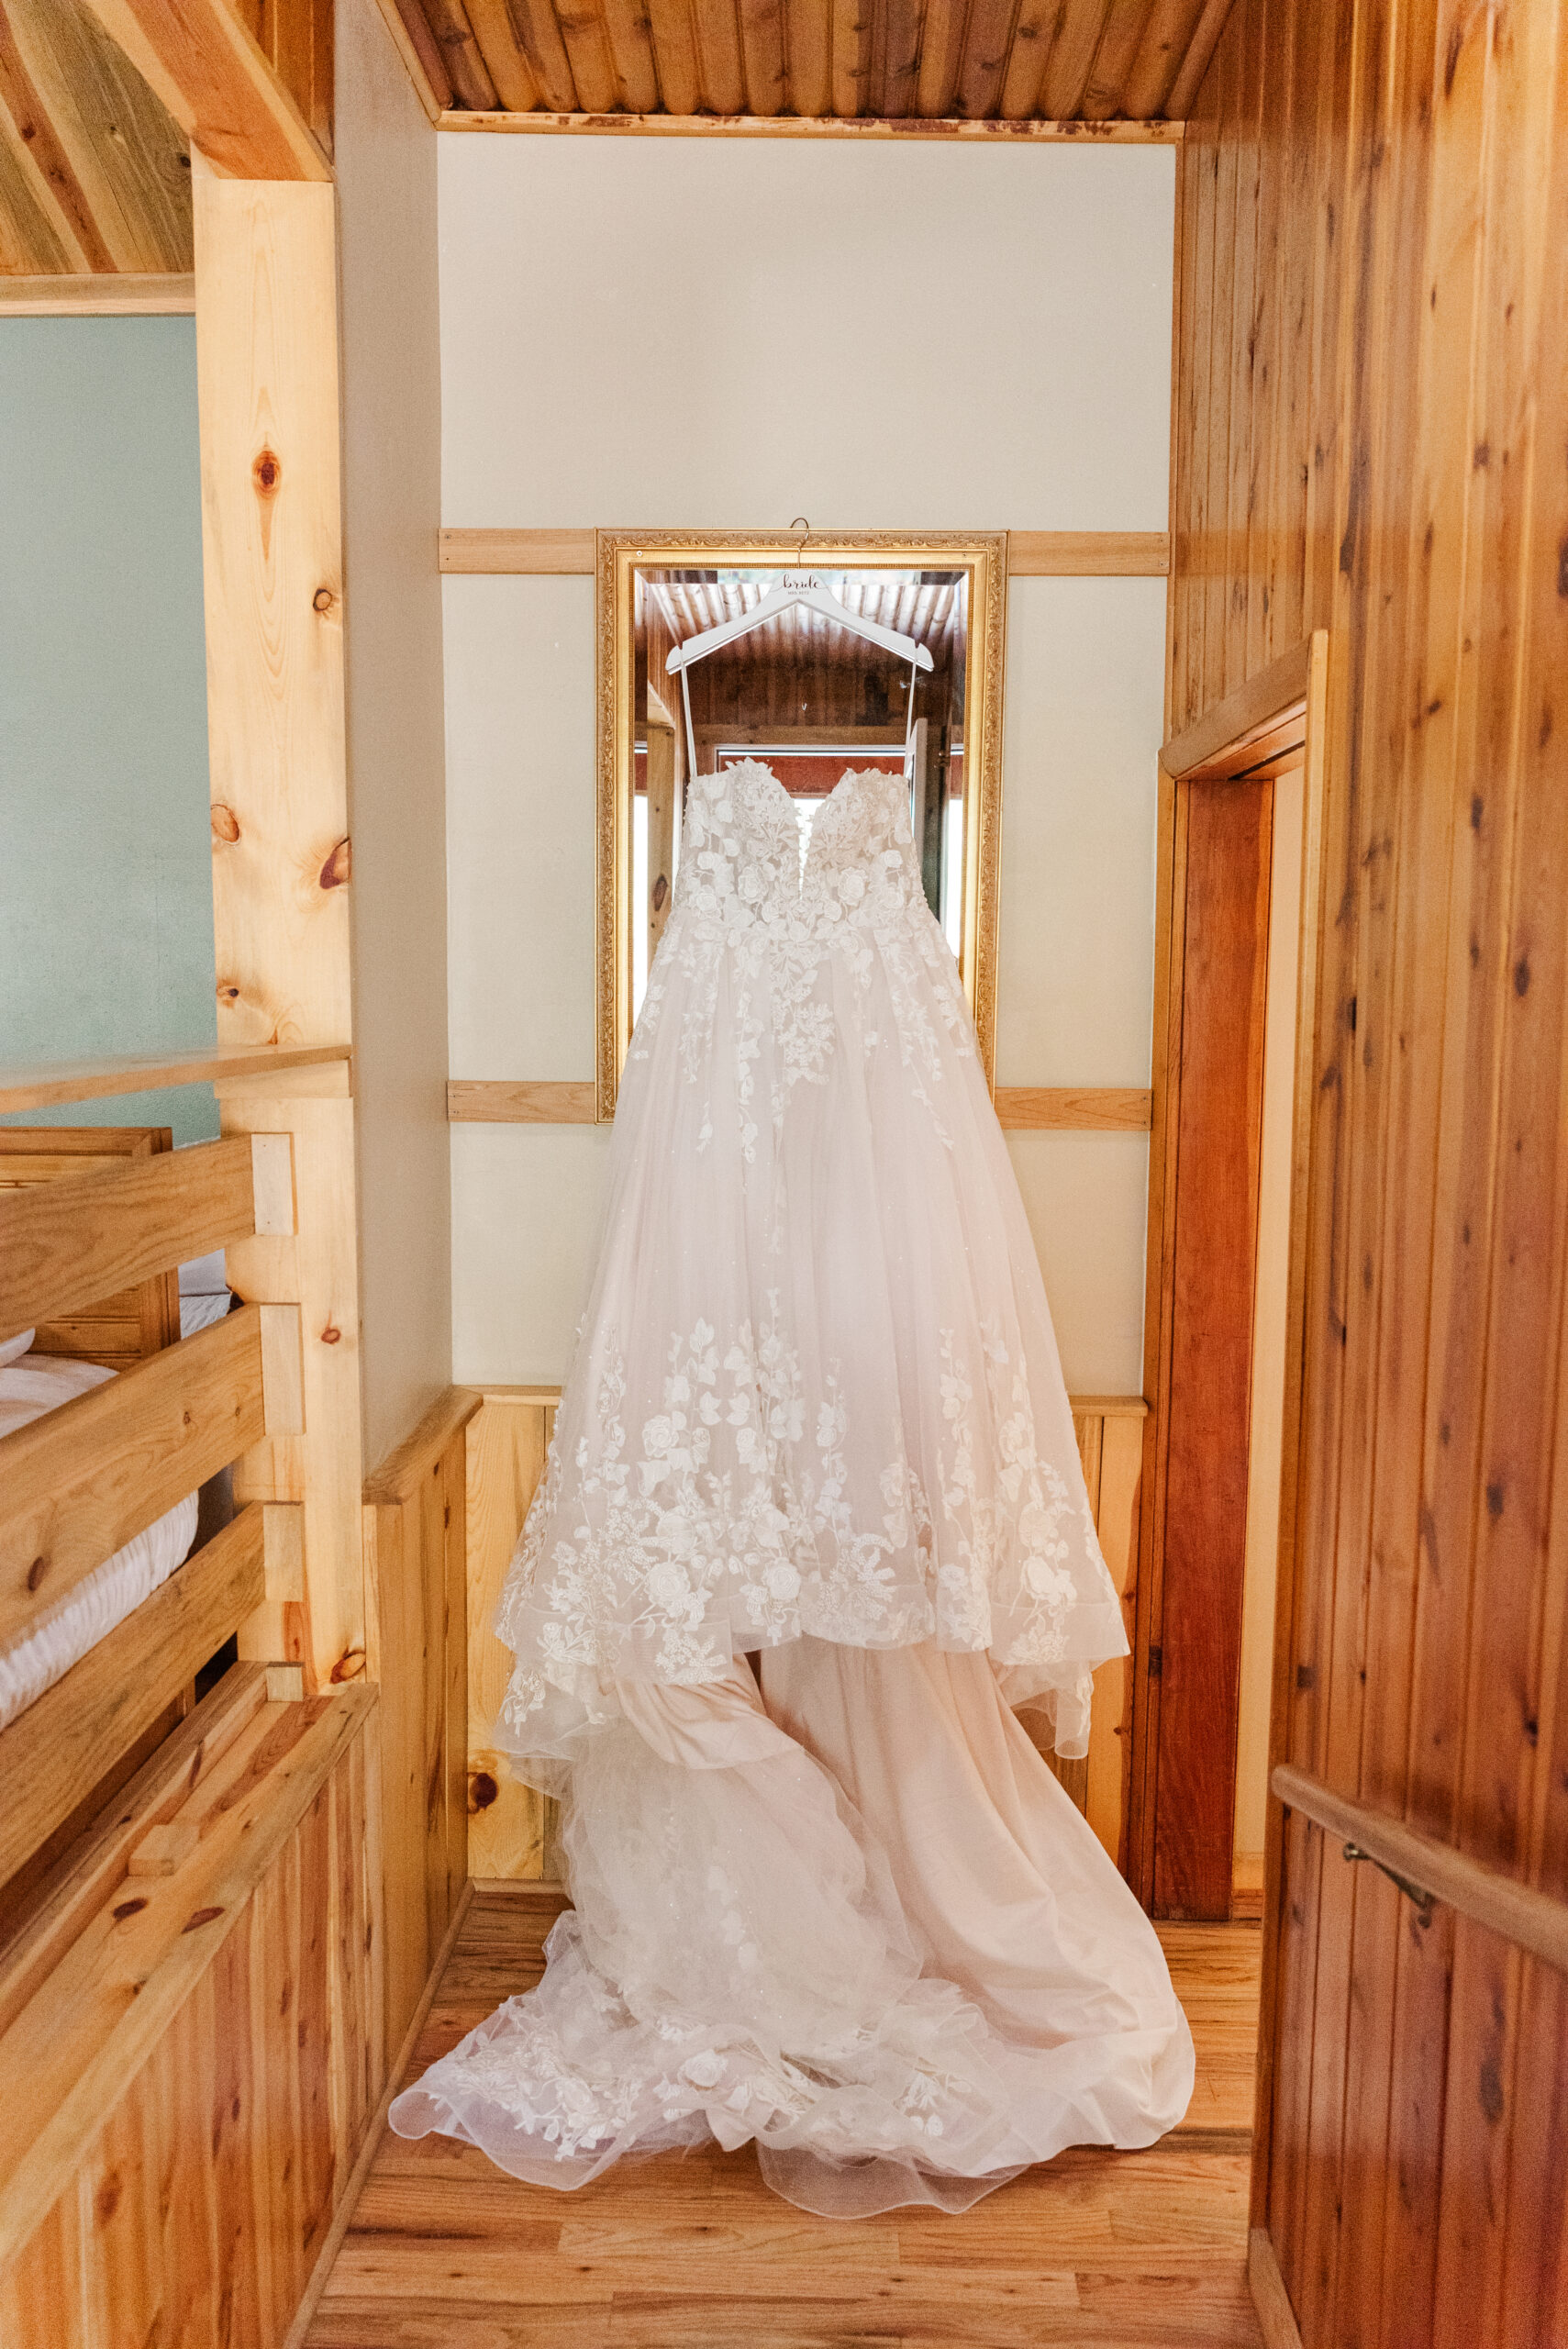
[0,1094,385,2344]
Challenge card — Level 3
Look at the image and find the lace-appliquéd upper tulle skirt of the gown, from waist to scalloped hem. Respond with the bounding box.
[497,902,1127,1765]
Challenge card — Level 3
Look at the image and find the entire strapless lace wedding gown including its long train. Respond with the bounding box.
[392,761,1193,2215]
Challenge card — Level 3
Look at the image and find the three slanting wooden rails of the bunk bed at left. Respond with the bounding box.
[0,1134,303,1884]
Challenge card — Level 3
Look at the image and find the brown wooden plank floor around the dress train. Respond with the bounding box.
[307,1891,1261,2349]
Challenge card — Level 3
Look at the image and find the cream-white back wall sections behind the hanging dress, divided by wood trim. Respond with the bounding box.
[439,136,1173,1393]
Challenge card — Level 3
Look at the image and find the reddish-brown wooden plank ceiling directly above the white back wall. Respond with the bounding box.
[392,0,1230,131]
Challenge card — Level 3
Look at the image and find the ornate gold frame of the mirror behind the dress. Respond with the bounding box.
[594,531,1007,1123]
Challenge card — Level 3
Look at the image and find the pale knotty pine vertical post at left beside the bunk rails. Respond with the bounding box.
[195,172,364,1687]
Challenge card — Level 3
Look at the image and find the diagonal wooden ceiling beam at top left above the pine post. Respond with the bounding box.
[84,0,331,181]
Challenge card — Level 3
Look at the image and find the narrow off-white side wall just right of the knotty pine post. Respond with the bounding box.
[336,0,450,1465]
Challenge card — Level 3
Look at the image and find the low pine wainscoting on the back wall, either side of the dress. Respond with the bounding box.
[467,1386,1145,1884]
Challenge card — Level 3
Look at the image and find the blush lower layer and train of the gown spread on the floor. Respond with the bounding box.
[392,1640,1193,2218]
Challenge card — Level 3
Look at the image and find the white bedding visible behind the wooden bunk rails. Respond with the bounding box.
[0,1353,199,1729]
